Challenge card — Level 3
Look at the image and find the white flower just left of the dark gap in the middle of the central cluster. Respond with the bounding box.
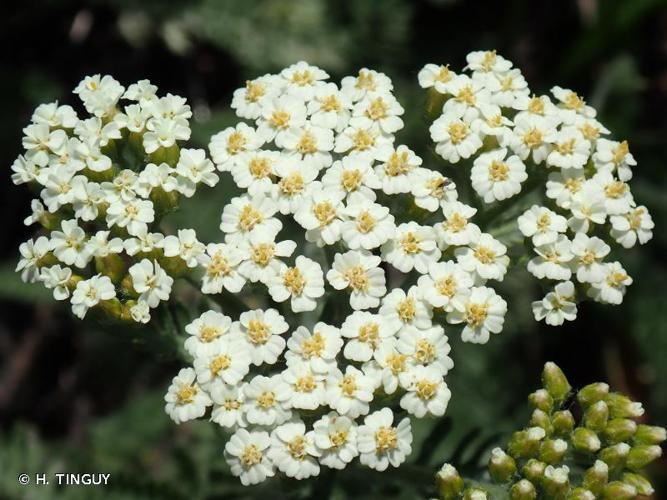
[267,255,324,312]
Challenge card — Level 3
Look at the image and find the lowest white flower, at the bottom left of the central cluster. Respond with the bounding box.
[225,429,275,486]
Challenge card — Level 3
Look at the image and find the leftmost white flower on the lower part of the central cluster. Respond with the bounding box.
[164,368,211,424]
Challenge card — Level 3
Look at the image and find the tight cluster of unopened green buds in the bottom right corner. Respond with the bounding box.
[436,363,667,500]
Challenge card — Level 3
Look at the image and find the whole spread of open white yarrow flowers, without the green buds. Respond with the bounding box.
[14,52,653,484]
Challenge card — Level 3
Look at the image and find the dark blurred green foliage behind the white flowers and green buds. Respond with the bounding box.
[0,0,667,500]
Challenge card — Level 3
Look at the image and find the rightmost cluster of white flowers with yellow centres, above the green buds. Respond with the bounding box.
[419,51,654,325]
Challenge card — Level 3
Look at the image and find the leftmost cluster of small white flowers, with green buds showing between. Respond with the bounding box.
[12,75,218,323]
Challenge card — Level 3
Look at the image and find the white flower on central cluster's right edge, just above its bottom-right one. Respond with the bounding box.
[399,366,451,418]
